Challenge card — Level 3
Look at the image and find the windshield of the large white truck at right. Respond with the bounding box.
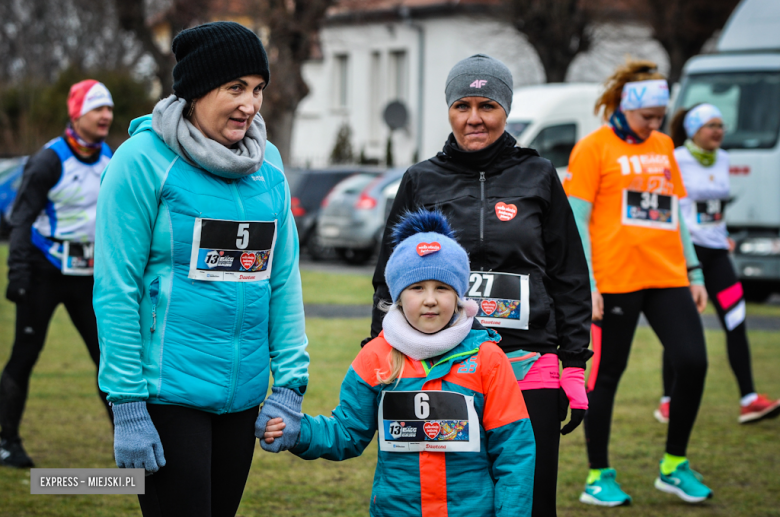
[678,72,780,149]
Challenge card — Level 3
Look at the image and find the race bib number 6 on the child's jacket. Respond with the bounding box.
[379,391,480,452]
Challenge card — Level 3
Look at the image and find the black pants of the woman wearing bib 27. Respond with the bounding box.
[523,389,561,517]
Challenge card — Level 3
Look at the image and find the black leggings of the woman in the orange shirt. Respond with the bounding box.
[585,287,707,469]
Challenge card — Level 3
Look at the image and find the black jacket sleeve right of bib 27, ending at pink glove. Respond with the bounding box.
[542,167,593,368]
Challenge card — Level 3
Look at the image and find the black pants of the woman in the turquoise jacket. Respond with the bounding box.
[138,403,259,517]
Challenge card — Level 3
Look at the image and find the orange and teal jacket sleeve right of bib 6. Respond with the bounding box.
[480,344,536,517]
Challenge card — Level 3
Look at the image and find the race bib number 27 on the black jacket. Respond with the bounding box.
[466,271,530,330]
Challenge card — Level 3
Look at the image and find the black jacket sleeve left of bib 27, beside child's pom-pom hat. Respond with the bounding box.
[360,171,416,346]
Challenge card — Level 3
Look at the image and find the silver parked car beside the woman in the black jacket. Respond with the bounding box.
[317,168,406,264]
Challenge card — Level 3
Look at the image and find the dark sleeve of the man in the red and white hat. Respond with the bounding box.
[8,149,62,286]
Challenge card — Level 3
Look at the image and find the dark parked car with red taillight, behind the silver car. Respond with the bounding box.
[285,166,380,260]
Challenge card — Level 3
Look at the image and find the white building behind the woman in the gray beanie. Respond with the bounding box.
[290,0,668,167]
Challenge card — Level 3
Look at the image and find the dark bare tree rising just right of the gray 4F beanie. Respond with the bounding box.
[497,0,593,83]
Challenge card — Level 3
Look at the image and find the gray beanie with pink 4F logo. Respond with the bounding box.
[444,54,513,115]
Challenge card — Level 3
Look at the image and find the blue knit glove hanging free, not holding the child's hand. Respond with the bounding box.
[112,402,165,472]
